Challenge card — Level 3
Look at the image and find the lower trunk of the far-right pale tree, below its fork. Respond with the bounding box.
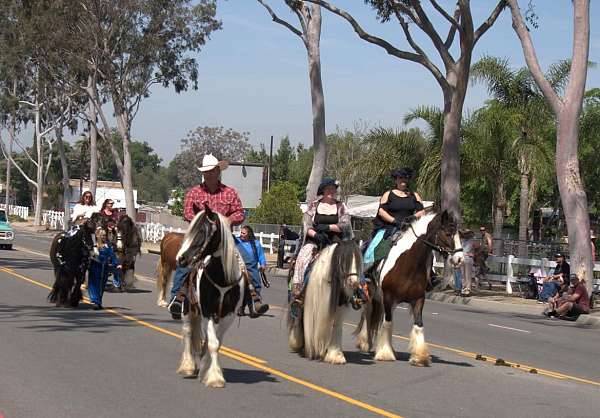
[556,112,594,291]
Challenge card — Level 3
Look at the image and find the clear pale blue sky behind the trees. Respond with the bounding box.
[68,0,600,164]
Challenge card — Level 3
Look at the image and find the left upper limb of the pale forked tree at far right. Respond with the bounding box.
[507,0,563,115]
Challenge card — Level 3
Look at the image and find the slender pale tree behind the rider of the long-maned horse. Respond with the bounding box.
[258,0,327,202]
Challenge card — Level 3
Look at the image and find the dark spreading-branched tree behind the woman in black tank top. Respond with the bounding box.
[304,0,506,219]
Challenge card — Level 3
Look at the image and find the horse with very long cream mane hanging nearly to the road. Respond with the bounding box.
[288,240,363,364]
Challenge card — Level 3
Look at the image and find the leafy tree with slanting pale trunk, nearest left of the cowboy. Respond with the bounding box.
[59,0,221,217]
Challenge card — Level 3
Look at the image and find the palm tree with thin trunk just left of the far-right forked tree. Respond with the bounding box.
[471,56,570,257]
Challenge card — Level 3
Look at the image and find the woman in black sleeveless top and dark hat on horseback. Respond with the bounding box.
[373,168,425,235]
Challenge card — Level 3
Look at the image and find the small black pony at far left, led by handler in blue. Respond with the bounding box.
[48,215,98,308]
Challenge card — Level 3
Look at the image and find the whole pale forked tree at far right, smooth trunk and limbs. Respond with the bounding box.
[507,0,593,291]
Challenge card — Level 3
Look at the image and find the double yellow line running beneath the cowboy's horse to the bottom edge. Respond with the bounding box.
[0,267,402,418]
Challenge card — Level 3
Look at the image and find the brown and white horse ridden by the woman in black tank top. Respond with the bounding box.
[355,210,464,366]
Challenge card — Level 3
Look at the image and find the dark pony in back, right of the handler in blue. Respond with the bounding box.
[111,214,142,291]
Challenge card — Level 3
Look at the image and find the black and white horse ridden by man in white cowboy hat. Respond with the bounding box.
[177,206,244,388]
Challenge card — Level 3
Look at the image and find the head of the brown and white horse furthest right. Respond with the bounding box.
[426,210,464,267]
